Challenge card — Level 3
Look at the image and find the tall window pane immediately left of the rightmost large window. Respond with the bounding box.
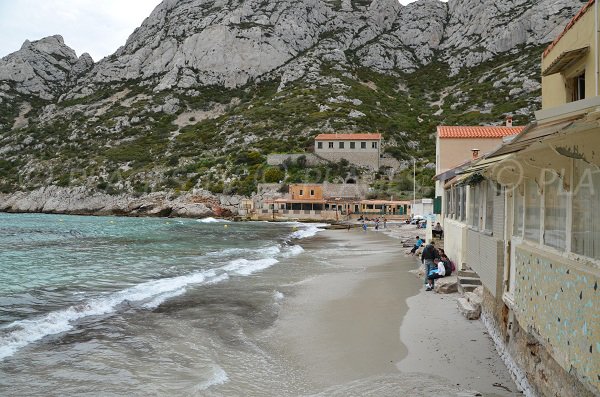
[544,171,567,250]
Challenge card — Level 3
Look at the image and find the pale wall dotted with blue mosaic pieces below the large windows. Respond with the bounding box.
[515,247,600,393]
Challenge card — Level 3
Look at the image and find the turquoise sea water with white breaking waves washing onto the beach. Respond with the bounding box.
[0,214,323,396]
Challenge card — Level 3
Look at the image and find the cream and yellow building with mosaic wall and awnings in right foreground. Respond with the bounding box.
[444,1,600,396]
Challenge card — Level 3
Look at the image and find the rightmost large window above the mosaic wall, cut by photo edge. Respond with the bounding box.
[571,160,600,259]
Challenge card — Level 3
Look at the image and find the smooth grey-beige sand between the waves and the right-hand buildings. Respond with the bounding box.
[271,229,519,396]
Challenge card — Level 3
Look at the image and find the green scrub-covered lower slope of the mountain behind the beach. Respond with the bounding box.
[0,47,541,198]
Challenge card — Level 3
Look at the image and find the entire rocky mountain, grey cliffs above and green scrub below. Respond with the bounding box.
[0,0,584,197]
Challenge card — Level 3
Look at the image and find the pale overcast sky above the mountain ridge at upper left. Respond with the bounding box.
[0,0,422,61]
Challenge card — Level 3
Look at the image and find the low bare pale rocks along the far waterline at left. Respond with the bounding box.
[0,186,243,218]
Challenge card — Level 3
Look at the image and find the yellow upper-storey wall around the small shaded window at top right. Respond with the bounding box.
[542,5,600,109]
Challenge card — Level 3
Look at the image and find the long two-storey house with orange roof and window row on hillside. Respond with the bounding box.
[315,134,381,170]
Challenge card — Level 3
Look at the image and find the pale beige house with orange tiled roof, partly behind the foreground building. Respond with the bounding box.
[435,117,524,197]
